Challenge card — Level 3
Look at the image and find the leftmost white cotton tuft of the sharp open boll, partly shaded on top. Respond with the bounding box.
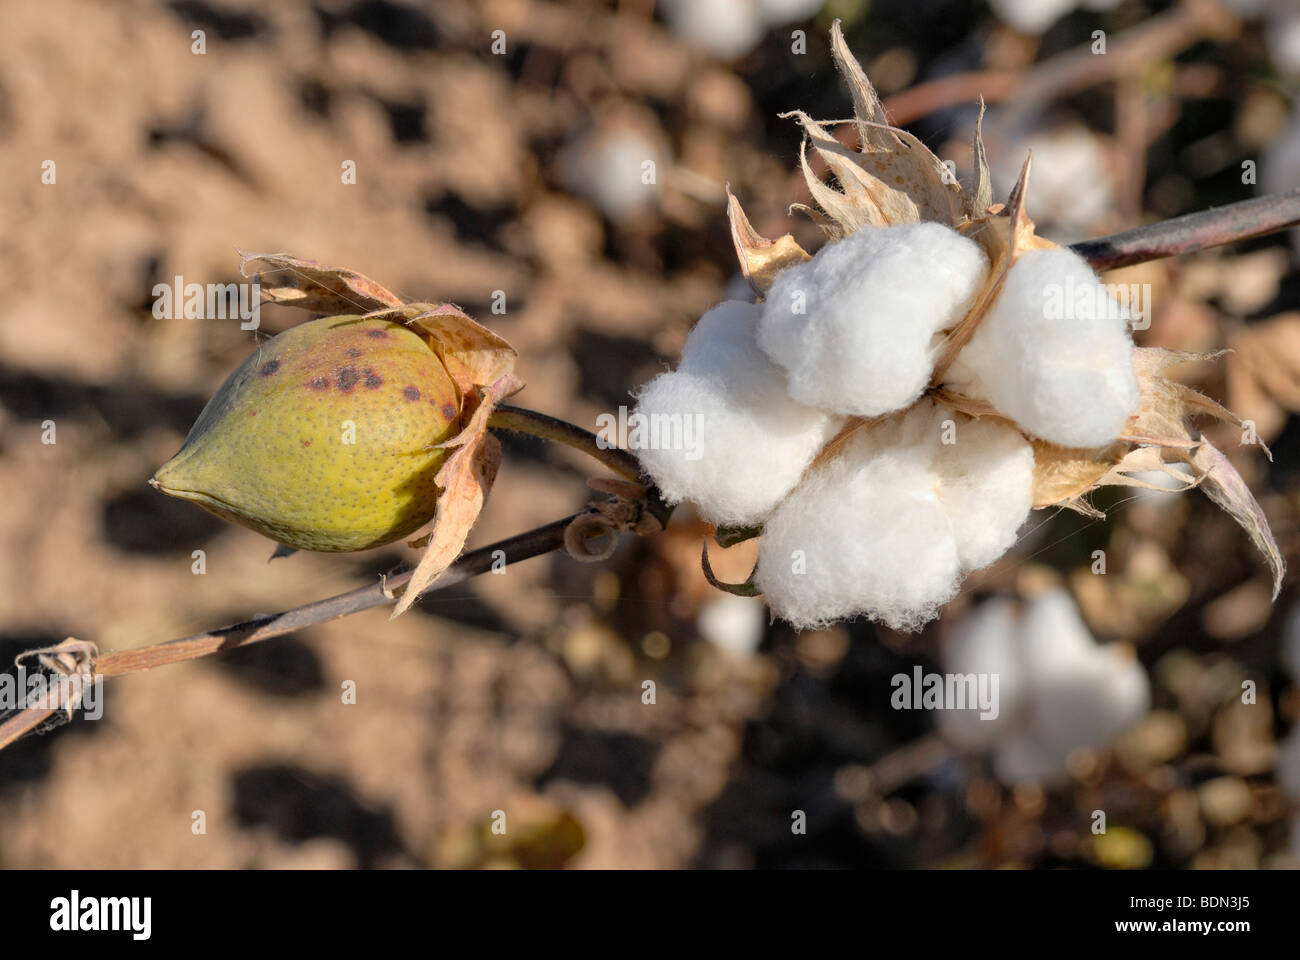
[628,300,840,524]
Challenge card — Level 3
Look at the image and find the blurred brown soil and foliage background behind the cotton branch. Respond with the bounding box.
[0,0,1300,868]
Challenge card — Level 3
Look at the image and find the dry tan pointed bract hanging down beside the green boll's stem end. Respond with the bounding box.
[393,375,521,617]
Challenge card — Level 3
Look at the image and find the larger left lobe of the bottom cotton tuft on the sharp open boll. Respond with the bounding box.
[755,416,961,631]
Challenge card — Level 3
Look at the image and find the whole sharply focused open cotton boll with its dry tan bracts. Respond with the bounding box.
[636,23,1283,631]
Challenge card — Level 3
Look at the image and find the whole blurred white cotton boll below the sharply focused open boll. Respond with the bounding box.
[939,588,1151,786]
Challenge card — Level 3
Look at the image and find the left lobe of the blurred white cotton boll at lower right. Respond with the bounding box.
[939,597,1024,749]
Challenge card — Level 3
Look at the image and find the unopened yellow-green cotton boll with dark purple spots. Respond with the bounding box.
[153,316,460,552]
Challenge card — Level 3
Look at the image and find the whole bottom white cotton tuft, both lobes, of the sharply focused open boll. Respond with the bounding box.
[757,399,1034,630]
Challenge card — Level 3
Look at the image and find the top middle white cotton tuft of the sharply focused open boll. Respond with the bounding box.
[758,222,988,416]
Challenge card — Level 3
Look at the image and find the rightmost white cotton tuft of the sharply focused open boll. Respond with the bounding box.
[945,243,1138,447]
